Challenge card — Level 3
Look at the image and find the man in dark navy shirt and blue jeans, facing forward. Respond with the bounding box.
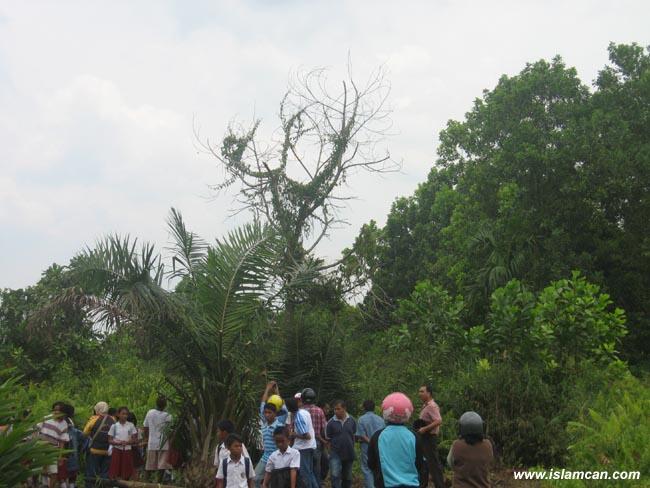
[326,400,357,488]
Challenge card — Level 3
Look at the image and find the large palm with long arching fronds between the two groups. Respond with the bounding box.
[59,209,283,487]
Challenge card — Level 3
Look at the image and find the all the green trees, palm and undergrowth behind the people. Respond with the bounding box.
[0,44,650,487]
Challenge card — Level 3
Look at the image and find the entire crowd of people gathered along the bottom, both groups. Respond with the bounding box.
[24,382,493,488]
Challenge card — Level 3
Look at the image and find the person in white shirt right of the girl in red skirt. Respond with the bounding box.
[143,396,172,482]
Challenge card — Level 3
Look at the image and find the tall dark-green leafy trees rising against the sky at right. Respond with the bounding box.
[347,45,650,363]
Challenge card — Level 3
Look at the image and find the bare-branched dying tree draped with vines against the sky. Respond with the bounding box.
[197,66,399,284]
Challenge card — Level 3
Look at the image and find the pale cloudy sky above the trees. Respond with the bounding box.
[0,0,650,288]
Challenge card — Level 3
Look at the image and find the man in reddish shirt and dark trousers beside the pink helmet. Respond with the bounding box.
[418,385,445,488]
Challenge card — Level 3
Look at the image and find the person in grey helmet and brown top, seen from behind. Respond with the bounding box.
[447,412,494,488]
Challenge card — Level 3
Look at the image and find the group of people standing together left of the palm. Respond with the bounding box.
[28,397,172,488]
